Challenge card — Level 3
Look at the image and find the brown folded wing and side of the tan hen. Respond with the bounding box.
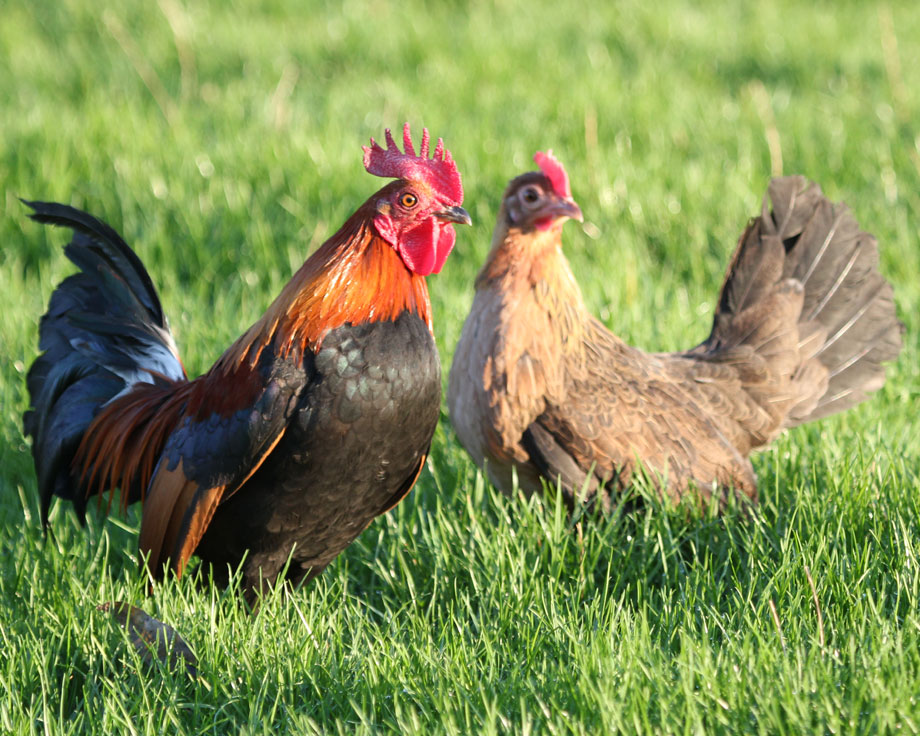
[522,322,756,505]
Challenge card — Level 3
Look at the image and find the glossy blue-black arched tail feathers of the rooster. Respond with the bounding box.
[23,202,186,523]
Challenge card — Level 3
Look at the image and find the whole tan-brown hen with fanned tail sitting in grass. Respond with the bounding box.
[448,153,902,509]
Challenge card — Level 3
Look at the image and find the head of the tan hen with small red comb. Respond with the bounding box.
[502,151,582,232]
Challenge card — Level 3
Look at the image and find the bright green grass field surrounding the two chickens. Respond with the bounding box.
[0,0,920,734]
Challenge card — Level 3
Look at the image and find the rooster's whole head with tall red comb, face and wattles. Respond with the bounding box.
[364,123,472,276]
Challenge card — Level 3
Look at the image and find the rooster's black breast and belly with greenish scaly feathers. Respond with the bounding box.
[221,314,441,544]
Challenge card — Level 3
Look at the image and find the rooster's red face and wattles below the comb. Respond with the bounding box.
[374,182,463,276]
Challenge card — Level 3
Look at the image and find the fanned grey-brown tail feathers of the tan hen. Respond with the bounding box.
[692,176,903,442]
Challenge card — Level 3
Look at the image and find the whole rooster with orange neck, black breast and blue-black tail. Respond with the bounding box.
[24,123,470,592]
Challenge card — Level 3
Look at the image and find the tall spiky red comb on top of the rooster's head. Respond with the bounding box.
[362,123,463,206]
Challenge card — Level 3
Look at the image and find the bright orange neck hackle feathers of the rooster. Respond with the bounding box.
[220,203,432,372]
